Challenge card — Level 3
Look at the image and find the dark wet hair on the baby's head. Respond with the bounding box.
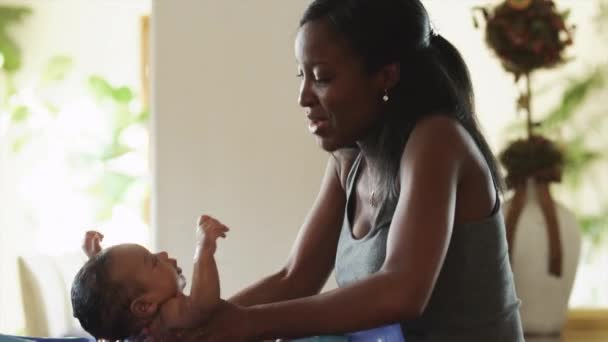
[71,250,143,341]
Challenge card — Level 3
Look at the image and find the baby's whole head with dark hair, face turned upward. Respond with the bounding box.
[72,244,185,341]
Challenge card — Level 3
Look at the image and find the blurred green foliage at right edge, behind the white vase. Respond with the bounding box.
[505,0,608,248]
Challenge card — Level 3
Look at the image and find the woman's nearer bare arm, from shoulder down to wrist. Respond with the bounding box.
[245,117,468,339]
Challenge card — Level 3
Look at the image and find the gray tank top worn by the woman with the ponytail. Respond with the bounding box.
[335,155,524,342]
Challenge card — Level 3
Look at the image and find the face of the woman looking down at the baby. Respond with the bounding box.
[295,21,384,151]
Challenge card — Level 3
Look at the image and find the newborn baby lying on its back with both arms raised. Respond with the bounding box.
[71,216,228,341]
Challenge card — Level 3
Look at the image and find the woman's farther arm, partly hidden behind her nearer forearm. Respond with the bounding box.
[229,158,346,306]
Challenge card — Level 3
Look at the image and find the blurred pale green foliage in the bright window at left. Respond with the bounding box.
[0,7,149,221]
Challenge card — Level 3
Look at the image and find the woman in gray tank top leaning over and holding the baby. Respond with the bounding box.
[196,0,523,342]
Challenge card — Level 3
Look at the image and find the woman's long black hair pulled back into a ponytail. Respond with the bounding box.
[300,0,503,198]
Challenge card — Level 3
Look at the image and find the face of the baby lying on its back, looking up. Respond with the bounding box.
[107,244,186,302]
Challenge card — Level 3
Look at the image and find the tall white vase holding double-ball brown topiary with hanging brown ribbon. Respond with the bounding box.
[476,0,581,335]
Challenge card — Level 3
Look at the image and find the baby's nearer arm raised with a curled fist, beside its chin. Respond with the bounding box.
[161,216,228,329]
